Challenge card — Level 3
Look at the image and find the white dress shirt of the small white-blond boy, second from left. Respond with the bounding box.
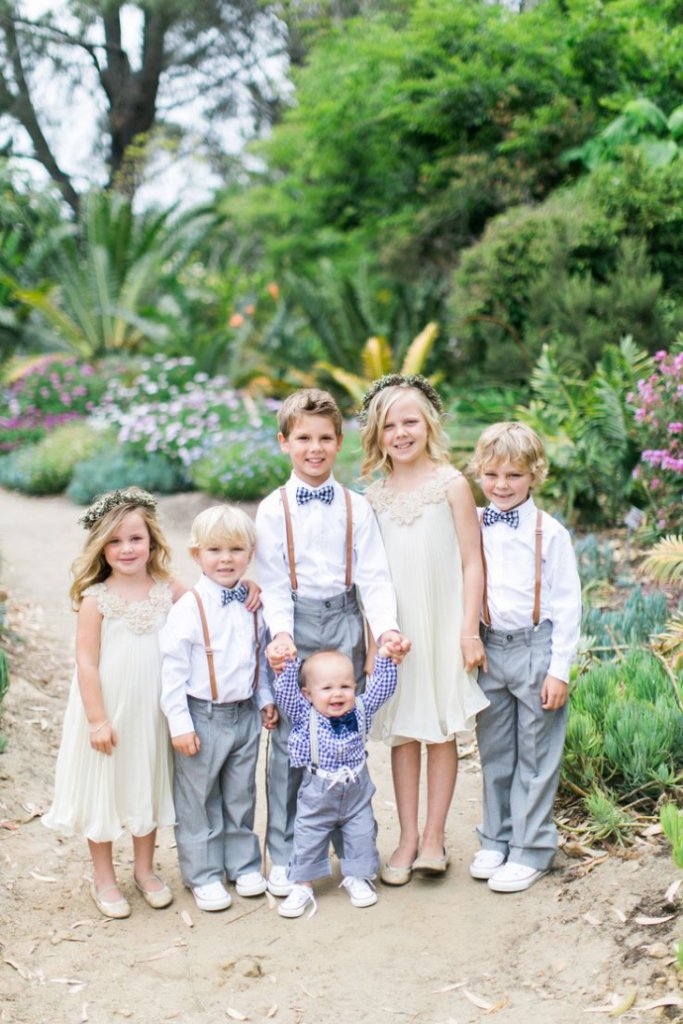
[159,575,274,736]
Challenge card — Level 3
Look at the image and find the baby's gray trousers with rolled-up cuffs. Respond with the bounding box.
[287,766,379,882]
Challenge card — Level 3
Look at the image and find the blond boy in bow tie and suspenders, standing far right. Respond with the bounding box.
[470,423,581,892]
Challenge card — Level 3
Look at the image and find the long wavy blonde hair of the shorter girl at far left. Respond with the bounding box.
[69,497,171,608]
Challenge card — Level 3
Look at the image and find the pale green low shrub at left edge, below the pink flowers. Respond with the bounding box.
[0,422,108,495]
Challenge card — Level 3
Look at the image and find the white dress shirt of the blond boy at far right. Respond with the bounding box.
[481,498,581,682]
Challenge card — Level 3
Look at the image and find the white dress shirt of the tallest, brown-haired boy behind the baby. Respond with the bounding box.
[255,473,398,638]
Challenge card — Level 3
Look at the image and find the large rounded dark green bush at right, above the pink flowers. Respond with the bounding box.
[450,160,683,380]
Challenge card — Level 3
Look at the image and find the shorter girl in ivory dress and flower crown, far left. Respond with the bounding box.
[43,487,183,918]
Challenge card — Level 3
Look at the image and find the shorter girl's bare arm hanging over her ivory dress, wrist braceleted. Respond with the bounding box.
[76,595,117,754]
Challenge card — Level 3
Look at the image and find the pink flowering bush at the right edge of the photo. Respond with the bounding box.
[628,351,683,534]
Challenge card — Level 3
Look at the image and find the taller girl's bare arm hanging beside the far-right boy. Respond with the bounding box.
[446,476,487,672]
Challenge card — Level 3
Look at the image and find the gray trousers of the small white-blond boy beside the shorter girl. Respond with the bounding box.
[173,697,261,888]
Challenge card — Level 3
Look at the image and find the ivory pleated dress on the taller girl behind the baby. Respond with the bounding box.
[366,465,488,746]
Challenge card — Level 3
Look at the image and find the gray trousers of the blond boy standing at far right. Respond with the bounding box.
[476,621,567,870]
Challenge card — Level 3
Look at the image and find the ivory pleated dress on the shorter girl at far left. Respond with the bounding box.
[43,583,175,843]
